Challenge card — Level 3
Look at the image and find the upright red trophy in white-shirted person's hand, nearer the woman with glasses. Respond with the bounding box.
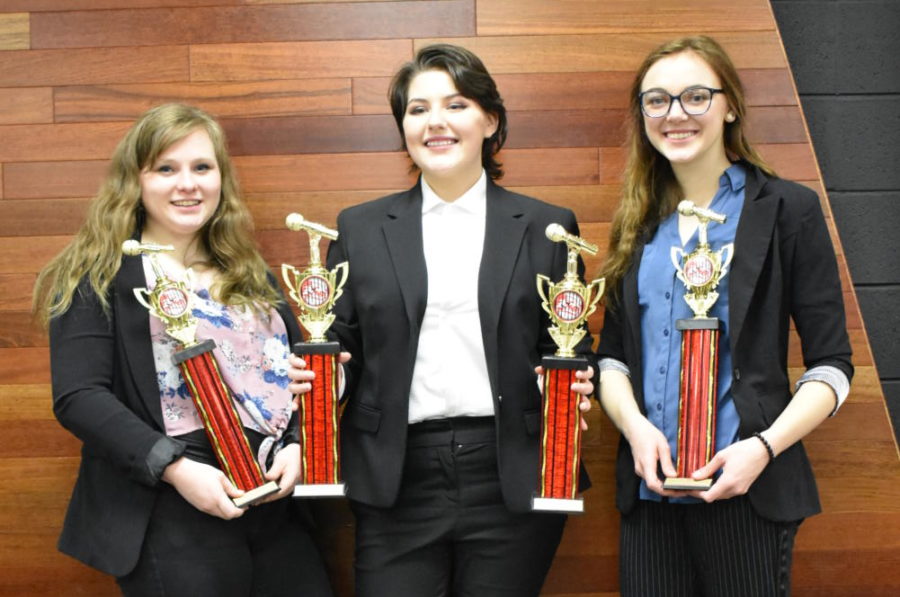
[531,224,605,512]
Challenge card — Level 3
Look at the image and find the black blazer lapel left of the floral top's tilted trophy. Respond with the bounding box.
[115,251,165,429]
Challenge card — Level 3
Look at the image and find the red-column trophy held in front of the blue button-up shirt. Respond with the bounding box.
[663,201,734,490]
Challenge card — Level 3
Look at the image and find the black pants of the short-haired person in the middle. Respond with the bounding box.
[352,417,565,597]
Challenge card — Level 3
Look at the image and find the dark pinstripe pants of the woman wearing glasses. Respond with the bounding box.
[619,496,802,597]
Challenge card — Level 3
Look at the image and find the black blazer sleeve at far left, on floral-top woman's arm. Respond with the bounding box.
[50,280,183,485]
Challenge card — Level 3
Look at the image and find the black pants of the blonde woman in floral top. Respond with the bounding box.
[117,484,332,597]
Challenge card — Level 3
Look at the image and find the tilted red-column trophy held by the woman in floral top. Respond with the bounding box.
[122,240,278,508]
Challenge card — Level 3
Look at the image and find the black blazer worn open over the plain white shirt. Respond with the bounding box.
[328,182,590,511]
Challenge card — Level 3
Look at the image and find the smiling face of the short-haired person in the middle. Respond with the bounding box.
[403,70,497,200]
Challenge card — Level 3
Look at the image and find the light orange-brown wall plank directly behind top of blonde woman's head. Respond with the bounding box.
[51,79,350,122]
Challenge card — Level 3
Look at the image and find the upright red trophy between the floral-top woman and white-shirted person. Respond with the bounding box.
[281,213,349,497]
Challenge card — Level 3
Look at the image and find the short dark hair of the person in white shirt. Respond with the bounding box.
[388,44,507,180]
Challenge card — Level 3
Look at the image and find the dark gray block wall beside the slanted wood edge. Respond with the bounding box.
[772,0,900,436]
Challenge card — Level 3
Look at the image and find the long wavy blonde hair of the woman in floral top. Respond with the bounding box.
[32,104,281,326]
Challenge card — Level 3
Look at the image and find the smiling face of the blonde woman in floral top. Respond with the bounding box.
[141,129,222,246]
